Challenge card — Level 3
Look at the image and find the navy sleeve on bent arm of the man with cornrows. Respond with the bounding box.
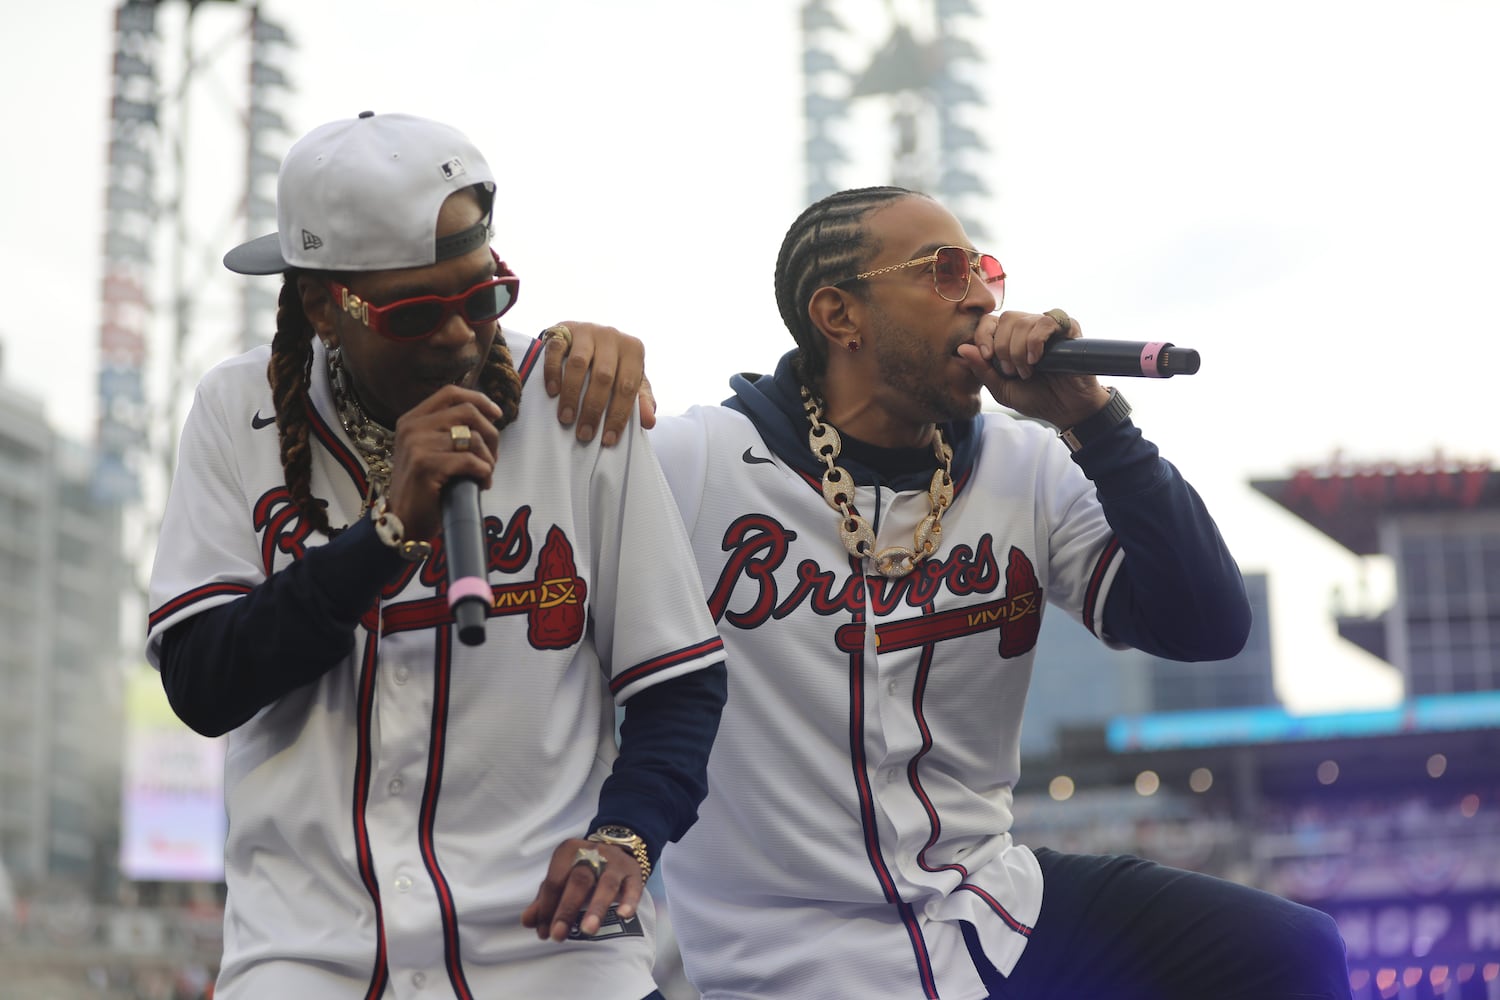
[1073,420,1250,660]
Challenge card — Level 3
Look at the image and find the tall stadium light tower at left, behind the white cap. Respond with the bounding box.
[93,0,290,507]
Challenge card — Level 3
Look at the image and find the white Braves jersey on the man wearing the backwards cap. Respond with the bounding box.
[149,331,723,1000]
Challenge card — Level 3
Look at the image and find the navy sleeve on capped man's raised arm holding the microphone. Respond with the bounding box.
[161,519,410,736]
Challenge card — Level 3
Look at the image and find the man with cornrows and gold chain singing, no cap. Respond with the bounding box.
[651,187,1350,1000]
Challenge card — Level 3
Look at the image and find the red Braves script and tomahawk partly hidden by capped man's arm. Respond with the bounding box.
[255,486,588,649]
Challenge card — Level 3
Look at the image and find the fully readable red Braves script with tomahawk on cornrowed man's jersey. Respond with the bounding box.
[708,514,1043,658]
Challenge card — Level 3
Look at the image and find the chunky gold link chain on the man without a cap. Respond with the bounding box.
[803,387,953,580]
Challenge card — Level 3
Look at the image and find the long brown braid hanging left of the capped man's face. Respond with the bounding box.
[266,268,336,538]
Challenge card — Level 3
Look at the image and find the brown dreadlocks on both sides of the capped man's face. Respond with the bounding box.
[266,268,521,538]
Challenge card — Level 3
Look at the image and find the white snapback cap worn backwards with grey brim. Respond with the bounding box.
[224,111,495,274]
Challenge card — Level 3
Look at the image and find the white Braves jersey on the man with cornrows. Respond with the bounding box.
[651,406,1119,1000]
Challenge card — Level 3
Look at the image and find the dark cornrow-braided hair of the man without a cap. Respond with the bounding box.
[776,186,926,390]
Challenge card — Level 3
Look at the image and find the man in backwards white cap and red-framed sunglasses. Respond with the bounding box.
[147,112,725,1000]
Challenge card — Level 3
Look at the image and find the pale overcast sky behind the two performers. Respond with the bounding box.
[0,0,1500,711]
